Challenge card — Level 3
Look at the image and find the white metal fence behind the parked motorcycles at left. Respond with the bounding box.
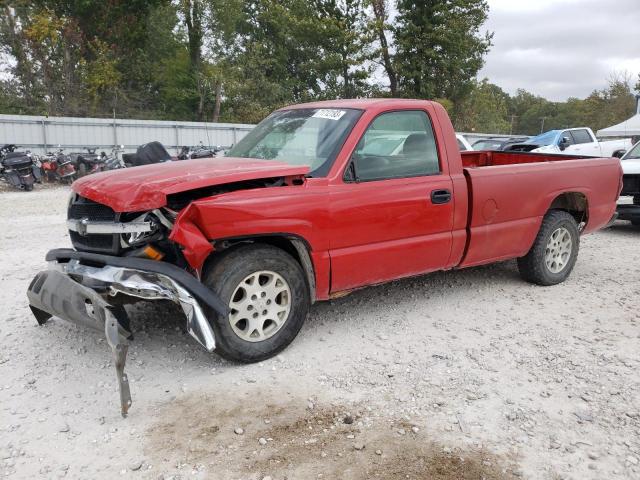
[0,115,253,153]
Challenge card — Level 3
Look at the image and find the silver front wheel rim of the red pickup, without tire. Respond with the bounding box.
[229,270,291,342]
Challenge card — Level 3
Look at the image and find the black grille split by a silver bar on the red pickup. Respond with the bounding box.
[67,196,120,255]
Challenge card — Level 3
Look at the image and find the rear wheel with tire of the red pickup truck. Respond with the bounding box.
[518,210,580,286]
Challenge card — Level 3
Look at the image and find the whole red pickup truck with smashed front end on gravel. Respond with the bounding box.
[28,99,621,410]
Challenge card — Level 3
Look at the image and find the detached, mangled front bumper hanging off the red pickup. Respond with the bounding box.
[27,249,227,416]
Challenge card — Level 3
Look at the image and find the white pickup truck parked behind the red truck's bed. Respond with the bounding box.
[509,127,631,157]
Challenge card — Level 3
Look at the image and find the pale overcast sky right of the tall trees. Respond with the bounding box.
[478,0,640,101]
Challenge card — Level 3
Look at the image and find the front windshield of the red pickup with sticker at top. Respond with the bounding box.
[227,108,362,177]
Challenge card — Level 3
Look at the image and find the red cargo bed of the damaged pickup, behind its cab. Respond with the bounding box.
[459,151,620,267]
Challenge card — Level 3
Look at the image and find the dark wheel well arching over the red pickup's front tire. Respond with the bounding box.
[206,234,316,303]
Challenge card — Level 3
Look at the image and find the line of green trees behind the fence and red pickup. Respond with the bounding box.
[0,0,640,134]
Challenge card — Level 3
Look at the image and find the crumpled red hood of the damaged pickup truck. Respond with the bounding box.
[73,157,309,212]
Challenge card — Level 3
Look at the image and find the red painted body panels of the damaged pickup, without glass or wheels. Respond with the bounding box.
[74,99,622,299]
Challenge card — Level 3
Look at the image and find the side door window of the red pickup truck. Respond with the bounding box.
[345,110,440,182]
